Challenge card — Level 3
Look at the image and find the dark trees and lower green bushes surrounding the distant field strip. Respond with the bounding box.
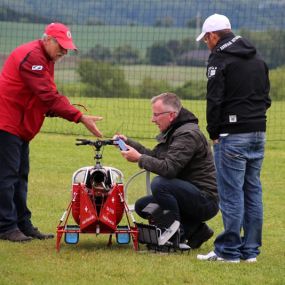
[74,30,285,100]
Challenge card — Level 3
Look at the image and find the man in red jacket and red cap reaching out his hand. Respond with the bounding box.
[0,23,102,242]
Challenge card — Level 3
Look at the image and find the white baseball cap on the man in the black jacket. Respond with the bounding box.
[196,14,231,42]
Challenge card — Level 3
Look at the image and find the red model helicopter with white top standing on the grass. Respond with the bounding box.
[56,139,138,251]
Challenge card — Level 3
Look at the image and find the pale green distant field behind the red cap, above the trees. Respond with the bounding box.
[0,22,195,53]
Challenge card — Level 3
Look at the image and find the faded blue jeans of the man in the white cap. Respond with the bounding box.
[214,132,265,259]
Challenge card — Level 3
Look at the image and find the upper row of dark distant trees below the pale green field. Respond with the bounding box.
[83,29,285,68]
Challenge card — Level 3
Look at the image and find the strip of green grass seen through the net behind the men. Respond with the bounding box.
[43,97,285,141]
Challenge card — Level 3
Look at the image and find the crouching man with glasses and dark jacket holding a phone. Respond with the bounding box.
[115,93,219,249]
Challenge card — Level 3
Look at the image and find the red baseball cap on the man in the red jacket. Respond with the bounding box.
[45,23,77,50]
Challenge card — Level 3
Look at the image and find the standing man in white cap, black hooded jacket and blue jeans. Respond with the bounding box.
[196,14,271,262]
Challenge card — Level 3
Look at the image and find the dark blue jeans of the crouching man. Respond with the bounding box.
[135,176,219,238]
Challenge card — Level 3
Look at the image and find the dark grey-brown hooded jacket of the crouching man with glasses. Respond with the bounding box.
[127,108,218,200]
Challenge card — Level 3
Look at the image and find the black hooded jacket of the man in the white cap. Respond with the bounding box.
[207,33,271,140]
